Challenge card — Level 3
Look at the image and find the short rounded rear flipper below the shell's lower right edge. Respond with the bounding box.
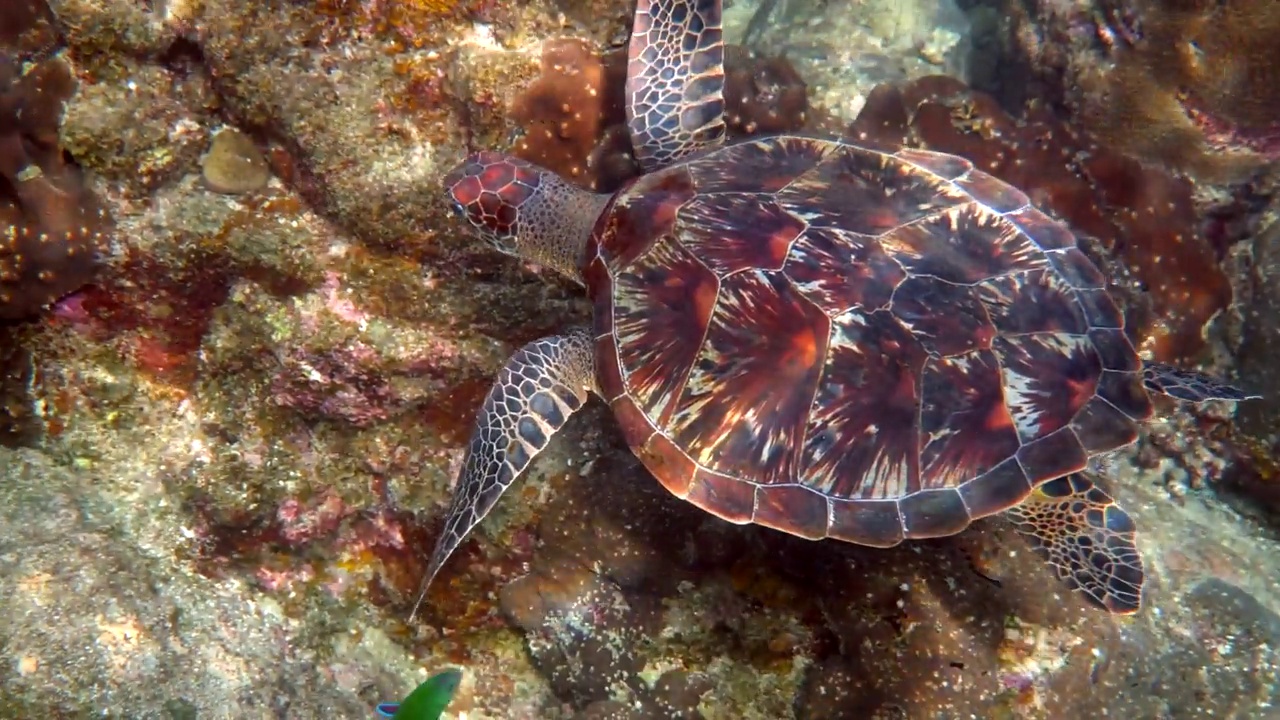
[1005,473,1144,615]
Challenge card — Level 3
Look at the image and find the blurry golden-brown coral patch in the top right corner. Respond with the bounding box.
[1080,0,1280,181]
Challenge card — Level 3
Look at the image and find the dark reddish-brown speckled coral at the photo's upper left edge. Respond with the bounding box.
[0,56,110,319]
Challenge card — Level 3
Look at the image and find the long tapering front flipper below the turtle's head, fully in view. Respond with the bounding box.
[410,328,596,620]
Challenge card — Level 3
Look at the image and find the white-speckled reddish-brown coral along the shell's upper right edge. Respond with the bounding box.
[849,76,1231,360]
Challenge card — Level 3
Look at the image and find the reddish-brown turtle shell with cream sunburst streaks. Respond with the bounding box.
[584,136,1152,547]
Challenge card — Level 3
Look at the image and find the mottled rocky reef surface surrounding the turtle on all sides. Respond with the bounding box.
[0,0,1280,719]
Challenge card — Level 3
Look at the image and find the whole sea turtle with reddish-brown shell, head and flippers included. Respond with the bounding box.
[415,0,1259,614]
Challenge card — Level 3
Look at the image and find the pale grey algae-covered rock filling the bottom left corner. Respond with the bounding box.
[0,450,424,717]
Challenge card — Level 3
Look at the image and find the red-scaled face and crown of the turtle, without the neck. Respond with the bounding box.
[444,151,544,242]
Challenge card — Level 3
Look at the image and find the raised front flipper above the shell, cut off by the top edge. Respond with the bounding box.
[627,0,724,173]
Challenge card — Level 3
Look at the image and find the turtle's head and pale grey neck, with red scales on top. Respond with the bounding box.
[444,151,608,279]
